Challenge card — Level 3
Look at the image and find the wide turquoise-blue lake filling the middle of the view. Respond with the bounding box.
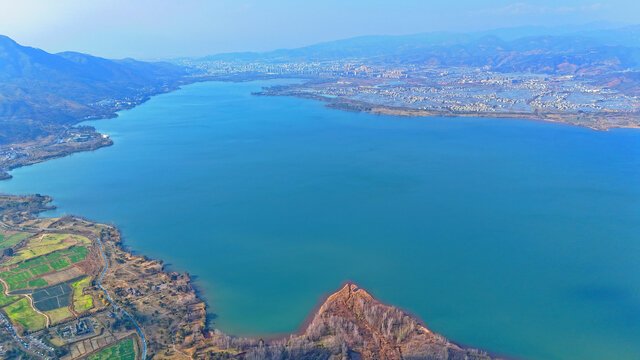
[0,82,640,359]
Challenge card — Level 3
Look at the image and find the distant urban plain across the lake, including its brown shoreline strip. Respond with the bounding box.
[182,60,640,130]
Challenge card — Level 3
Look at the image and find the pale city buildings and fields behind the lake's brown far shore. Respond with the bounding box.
[184,60,640,113]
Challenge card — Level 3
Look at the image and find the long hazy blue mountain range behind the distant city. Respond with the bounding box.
[203,26,640,73]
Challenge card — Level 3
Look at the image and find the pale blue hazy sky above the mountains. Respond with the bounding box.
[0,0,640,59]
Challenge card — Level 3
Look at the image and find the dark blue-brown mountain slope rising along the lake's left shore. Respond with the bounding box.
[0,35,186,145]
